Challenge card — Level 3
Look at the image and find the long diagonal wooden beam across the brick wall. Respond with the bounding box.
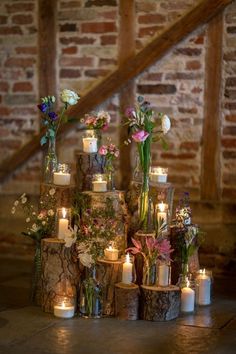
[0,0,232,181]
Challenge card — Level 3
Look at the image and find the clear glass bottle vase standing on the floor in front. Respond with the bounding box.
[80,266,102,318]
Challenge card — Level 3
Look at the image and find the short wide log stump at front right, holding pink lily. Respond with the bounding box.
[140,285,180,322]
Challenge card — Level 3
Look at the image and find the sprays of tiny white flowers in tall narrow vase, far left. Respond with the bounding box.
[11,188,56,301]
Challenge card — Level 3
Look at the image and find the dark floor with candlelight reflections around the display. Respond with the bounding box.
[0,259,236,354]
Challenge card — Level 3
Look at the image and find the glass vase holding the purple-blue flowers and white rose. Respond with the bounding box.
[43,138,57,184]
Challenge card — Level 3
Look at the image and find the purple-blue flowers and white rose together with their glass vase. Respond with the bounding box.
[38,89,80,183]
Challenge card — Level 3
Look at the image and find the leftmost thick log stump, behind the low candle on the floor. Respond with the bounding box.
[42,238,79,312]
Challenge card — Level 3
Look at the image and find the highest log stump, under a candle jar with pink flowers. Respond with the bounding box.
[76,152,104,191]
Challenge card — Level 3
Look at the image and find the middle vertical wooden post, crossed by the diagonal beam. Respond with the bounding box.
[118,0,136,190]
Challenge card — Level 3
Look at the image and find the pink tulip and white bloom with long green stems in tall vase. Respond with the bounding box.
[125,96,171,231]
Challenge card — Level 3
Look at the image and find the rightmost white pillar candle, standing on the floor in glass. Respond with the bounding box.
[196,269,211,305]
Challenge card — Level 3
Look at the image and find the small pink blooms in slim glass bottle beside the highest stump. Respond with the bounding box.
[98,143,120,190]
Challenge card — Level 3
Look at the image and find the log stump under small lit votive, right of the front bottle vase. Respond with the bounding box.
[96,259,122,316]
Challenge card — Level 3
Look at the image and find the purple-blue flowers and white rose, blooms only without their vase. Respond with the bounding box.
[38,89,80,145]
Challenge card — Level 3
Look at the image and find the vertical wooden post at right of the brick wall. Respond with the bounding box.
[201,14,223,201]
